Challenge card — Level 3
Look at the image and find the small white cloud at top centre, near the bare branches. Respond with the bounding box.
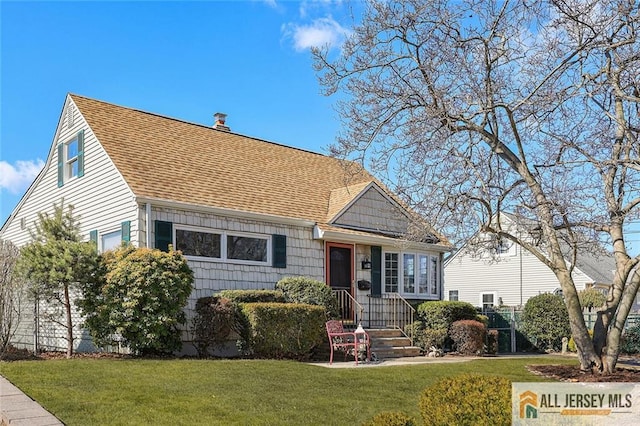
[283,17,350,52]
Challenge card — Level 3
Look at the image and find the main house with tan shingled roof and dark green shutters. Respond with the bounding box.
[0,94,451,349]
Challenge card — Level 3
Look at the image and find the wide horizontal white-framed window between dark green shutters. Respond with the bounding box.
[174,225,271,264]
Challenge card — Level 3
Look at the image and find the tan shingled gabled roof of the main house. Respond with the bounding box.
[69,95,448,244]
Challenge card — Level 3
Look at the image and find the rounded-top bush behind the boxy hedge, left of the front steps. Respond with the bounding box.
[276,277,339,319]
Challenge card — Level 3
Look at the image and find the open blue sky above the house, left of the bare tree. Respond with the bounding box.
[0,0,358,225]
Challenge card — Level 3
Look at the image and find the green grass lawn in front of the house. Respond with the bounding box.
[0,356,576,425]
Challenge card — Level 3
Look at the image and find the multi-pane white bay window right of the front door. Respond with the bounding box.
[384,253,440,297]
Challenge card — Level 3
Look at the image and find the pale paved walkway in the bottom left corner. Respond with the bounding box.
[0,376,63,426]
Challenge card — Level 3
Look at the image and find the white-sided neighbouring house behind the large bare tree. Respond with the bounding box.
[443,213,615,310]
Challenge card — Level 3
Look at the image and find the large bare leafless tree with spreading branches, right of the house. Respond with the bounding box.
[313,0,640,373]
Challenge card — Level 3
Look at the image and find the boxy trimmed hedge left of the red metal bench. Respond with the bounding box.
[241,303,326,360]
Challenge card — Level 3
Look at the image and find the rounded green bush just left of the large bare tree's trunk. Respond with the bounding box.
[522,293,571,351]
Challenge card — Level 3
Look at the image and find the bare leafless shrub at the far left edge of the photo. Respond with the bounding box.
[0,240,24,359]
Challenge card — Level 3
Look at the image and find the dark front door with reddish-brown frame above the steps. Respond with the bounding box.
[327,243,353,319]
